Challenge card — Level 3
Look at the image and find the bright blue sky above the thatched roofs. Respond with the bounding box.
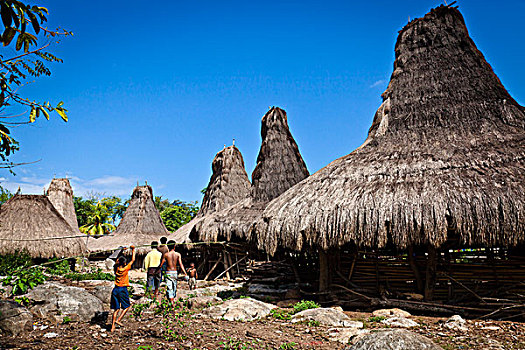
[0,0,525,201]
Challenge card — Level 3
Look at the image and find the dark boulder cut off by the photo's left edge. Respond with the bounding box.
[0,300,33,336]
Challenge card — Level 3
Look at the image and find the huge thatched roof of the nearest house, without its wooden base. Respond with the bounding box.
[257,6,525,253]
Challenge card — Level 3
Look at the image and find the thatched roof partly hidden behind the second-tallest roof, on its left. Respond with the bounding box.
[170,146,250,243]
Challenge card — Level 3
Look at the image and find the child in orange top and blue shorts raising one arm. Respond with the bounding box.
[110,246,135,332]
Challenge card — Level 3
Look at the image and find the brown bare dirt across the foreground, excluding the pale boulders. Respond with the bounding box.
[0,282,525,350]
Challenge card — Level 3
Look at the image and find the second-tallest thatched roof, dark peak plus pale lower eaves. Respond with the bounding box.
[192,107,309,241]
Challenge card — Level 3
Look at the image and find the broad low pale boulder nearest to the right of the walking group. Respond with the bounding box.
[199,298,276,321]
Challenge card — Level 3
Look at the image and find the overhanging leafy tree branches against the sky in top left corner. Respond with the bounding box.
[0,0,72,168]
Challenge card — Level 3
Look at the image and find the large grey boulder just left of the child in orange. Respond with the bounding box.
[26,283,104,322]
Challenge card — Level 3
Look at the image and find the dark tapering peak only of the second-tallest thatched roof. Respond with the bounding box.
[252,107,309,202]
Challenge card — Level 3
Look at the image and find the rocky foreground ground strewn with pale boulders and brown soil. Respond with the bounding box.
[0,281,525,350]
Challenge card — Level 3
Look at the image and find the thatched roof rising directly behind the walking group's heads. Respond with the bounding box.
[88,185,169,254]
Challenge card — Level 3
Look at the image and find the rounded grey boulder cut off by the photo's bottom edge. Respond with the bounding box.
[346,329,443,350]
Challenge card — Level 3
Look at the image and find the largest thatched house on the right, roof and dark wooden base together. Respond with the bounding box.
[252,6,525,311]
